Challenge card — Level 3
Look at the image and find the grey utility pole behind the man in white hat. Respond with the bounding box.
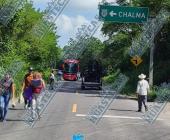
[149,41,155,87]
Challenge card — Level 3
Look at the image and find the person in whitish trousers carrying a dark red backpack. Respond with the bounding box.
[31,72,45,119]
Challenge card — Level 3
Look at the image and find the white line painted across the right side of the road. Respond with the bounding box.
[76,114,163,120]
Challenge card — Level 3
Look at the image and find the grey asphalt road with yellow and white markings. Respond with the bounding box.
[0,81,170,140]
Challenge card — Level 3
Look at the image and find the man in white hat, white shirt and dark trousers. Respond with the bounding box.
[136,73,149,112]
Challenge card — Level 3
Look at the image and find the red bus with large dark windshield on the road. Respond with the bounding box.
[63,59,79,81]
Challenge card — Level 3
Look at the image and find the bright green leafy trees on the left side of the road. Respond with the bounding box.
[0,0,61,95]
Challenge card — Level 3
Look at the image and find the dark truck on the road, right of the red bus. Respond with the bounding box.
[81,60,102,90]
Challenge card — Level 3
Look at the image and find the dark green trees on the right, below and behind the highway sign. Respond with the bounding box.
[102,0,170,92]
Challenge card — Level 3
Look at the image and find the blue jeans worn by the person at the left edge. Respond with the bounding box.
[0,93,10,120]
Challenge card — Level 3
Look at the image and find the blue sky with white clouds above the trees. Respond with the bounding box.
[33,0,115,47]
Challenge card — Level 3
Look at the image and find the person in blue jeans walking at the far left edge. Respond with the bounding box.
[0,74,15,122]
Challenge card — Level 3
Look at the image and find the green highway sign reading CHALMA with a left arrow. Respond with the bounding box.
[99,5,149,23]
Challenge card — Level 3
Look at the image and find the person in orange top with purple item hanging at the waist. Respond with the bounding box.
[21,67,33,109]
